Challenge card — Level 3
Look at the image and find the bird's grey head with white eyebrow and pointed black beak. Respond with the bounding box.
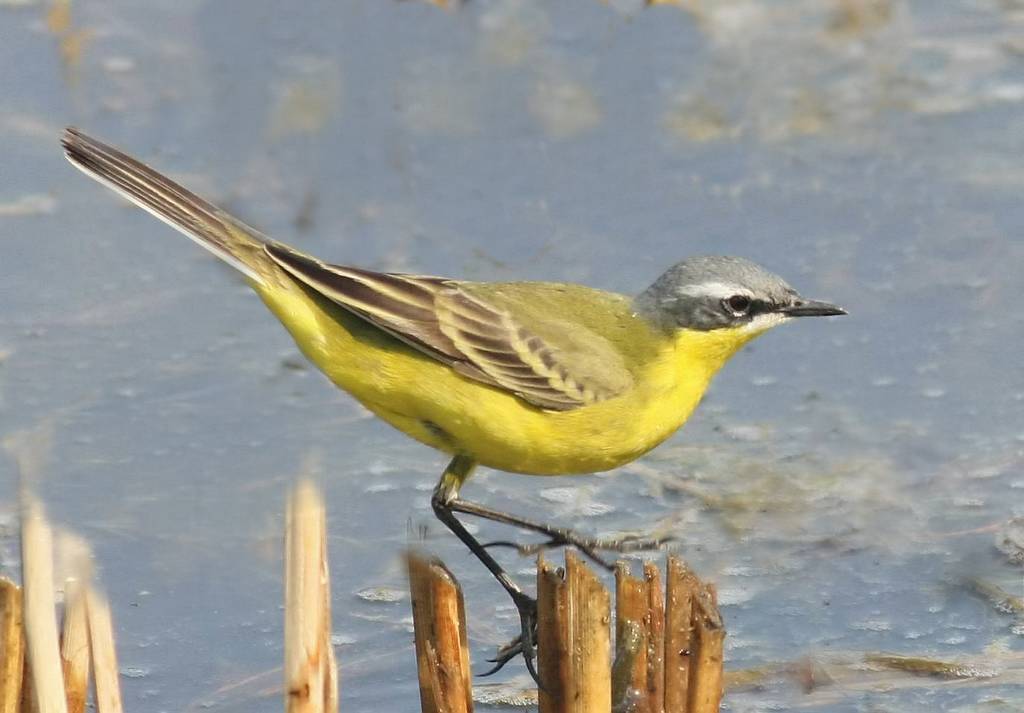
[636,255,846,332]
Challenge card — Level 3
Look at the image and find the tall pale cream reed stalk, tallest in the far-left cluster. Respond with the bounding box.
[22,494,68,713]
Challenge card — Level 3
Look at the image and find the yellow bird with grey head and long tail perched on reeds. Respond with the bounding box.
[61,127,847,681]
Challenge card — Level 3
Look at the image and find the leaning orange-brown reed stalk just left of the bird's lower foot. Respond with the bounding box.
[407,552,473,713]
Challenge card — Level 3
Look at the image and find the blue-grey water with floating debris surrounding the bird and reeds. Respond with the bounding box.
[0,0,1024,712]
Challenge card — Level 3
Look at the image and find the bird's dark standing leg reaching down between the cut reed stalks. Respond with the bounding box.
[430,456,541,685]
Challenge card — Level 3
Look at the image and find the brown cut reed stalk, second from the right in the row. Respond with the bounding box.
[665,555,699,713]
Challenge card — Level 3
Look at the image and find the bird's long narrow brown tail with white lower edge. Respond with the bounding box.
[60,127,281,284]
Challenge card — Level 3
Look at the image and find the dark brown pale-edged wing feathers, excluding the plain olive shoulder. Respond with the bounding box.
[266,243,618,411]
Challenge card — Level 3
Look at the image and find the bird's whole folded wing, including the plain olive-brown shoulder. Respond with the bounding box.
[266,244,633,411]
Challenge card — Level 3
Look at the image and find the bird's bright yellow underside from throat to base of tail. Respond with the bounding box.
[260,280,717,475]
